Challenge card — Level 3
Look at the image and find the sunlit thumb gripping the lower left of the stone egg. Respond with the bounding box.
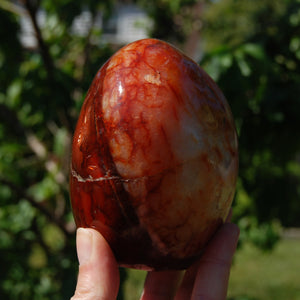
[71,228,120,300]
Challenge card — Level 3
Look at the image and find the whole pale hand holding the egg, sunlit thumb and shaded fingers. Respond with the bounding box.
[71,213,239,300]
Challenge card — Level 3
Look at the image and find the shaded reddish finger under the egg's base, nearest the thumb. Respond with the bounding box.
[141,271,182,300]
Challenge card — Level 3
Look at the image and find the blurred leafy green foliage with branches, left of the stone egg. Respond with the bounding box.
[0,1,113,299]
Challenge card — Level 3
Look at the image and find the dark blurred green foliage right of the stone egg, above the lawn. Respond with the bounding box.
[202,0,300,249]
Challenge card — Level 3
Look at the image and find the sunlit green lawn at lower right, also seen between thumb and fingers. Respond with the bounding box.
[123,239,300,300]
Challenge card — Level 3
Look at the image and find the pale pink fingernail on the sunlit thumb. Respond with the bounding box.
[76,228,93,265]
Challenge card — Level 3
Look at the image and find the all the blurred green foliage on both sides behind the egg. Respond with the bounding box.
[0,0,300,300]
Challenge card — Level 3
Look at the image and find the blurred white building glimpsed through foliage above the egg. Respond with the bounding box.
[20,3,152,48]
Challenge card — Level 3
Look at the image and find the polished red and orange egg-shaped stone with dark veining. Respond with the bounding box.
[70,39,238,270]
